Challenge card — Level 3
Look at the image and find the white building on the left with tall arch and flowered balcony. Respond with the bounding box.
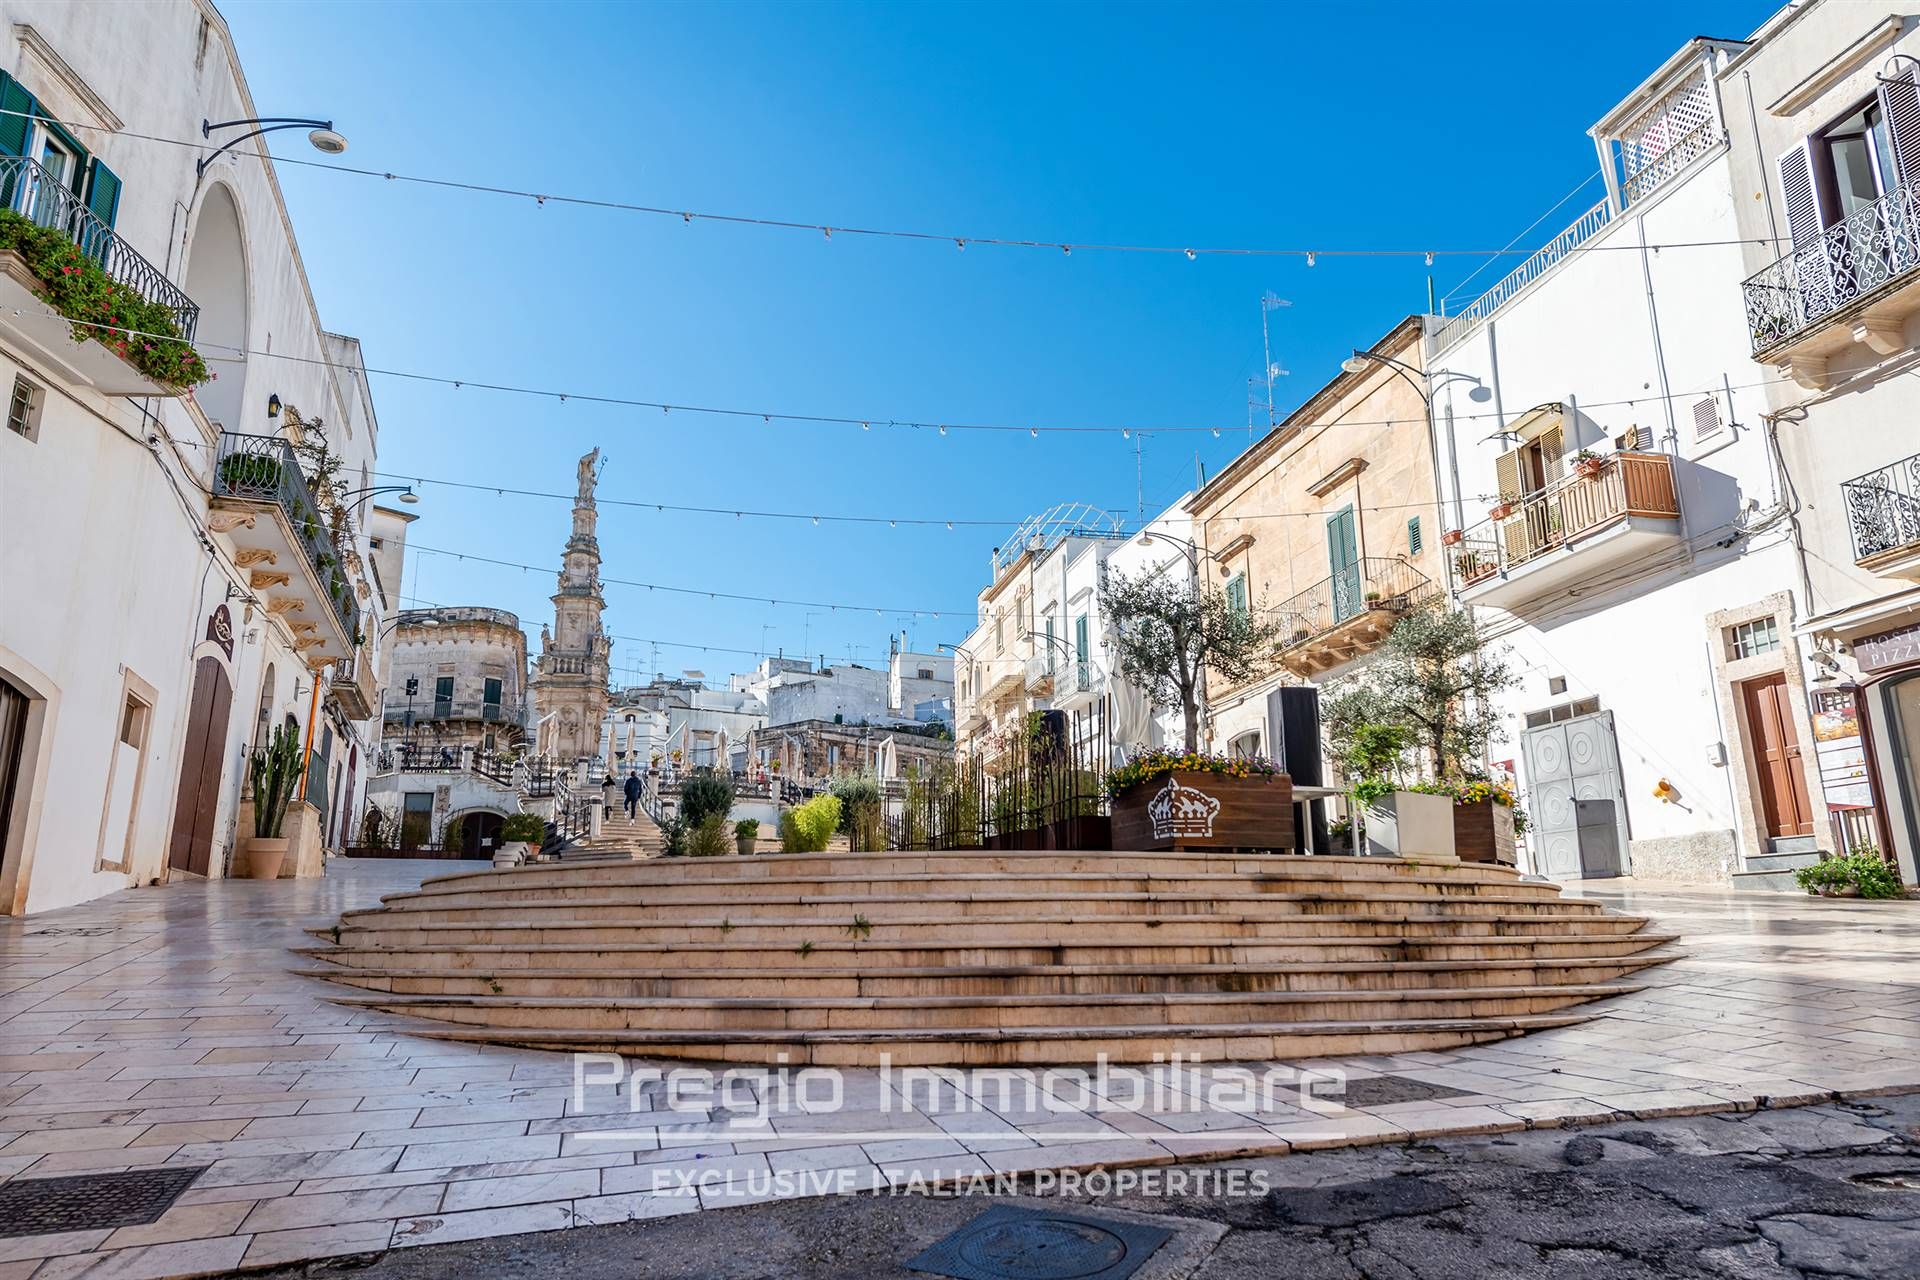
[0,0,397,912]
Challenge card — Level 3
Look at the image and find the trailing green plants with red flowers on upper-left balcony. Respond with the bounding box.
[0,209,207,388]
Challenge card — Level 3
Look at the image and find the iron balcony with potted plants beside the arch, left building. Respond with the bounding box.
[213,432,359,658]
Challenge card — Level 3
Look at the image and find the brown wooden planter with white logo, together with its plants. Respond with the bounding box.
[1106,750,1294,854]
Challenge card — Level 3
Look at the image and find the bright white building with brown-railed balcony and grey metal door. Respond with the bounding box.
[1427,32,1832,881]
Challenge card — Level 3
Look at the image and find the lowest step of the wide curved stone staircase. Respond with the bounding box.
[334,1013,1588,1074]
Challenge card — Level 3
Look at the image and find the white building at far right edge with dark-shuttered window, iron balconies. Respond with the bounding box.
[1720,0,1920,883]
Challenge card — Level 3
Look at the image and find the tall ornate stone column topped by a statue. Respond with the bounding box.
[534,449,612,762]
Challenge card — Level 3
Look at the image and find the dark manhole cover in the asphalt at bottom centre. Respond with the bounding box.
[906,1205,1173,1280]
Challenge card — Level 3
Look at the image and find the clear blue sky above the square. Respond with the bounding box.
[223,0,1772,681]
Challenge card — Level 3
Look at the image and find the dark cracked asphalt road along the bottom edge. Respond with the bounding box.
[255,1096,1920,1280]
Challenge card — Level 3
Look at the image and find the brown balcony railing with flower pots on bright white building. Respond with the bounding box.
[1452,453,1680,587]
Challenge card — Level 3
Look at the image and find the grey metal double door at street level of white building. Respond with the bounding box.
[1521,712,1626,881]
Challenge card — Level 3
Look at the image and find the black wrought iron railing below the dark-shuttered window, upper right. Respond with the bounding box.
[1741,182,1920,353]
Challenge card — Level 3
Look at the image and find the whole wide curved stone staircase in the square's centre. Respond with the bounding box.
[301,852,1672,1065]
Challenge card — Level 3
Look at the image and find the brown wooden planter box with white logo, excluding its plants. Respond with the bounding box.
[1114,771,1294,854]
